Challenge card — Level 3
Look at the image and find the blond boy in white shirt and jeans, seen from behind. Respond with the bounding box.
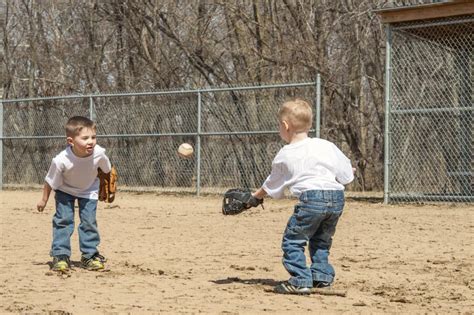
[251,99,355,294]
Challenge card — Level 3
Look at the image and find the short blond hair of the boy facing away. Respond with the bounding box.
[278,98,313,132]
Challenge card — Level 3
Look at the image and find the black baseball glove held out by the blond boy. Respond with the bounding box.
[222,188,263,215]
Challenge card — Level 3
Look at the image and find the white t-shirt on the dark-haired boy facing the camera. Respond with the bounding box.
[45,145,111,200]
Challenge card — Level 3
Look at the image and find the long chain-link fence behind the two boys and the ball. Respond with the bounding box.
[0,81,320,195]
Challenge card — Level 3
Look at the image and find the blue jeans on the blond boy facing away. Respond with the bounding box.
[282,190,344,287]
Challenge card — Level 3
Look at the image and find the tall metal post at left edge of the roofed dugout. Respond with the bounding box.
[383,25,392,204]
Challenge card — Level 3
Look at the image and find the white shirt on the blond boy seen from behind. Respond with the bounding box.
[262,138,354,198]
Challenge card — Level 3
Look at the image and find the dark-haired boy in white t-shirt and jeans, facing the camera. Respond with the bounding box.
[37,116,111,271]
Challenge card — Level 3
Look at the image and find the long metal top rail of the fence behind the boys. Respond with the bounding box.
[0,82,316,103]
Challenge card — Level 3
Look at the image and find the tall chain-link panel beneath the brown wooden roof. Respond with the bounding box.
[385,15,474,202]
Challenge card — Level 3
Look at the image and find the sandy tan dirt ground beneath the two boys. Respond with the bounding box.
[0,191,474,314]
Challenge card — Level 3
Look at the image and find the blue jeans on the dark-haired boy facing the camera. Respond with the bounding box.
[50,190,100,258]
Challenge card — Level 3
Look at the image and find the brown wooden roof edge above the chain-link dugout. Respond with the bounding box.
[375,0,474,23]
